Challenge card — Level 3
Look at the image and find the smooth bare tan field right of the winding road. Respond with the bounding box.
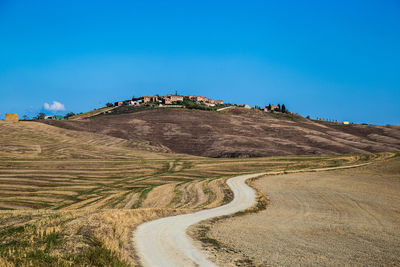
[209,159,400,266]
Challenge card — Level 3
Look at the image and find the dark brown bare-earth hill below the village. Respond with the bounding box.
[43,108,400,157]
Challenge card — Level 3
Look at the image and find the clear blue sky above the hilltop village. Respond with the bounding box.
[0,0,400,124]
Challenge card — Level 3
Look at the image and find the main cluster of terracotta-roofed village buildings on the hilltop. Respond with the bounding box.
[114,95,224,107]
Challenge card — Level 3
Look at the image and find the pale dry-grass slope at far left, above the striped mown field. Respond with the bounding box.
[0,121,169,159]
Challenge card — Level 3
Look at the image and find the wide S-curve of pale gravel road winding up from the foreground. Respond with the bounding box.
[133,173,264,267]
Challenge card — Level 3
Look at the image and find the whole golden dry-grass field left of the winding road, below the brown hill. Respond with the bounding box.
[0,121,395,266]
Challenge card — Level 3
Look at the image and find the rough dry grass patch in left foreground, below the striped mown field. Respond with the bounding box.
[0,209,189,266]
